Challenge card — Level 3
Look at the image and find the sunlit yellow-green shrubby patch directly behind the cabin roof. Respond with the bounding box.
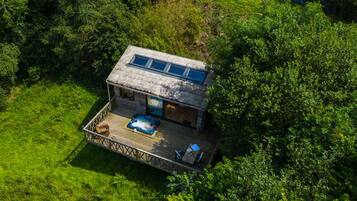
[130,0,208,58]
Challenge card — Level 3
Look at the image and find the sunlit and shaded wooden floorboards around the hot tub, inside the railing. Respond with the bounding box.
[97,106,218,166]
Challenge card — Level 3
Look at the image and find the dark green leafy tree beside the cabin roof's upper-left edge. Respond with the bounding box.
[78,2,130,80]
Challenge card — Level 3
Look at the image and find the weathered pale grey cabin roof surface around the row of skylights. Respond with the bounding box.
[107,45,213,110]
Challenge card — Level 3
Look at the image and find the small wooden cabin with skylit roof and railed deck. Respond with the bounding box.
[84,46,218,172]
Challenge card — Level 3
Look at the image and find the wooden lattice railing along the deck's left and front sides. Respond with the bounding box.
[83,100,199,173]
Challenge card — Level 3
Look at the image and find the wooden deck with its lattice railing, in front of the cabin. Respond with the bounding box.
[84,100,218,172]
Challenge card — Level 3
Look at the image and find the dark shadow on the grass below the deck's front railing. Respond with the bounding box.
[69,144,169,190]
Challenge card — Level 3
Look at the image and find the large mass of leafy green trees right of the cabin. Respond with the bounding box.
[170,2,357,200]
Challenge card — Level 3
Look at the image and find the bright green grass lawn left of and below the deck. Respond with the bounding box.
[0,82,167,200]
